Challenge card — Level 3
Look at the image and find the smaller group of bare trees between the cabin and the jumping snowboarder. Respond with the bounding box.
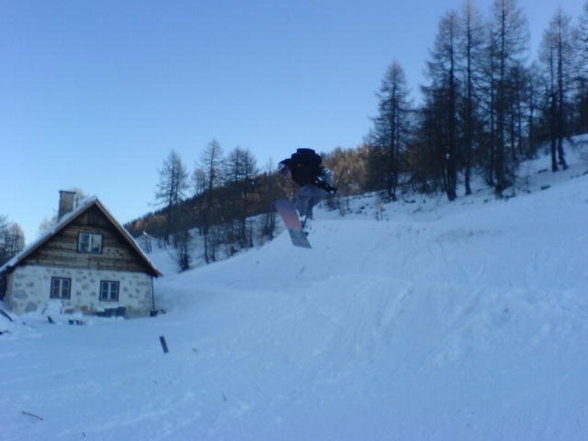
[125,144,304,269]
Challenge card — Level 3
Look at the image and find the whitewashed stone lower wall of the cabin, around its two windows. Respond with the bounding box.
[4,265,153,317]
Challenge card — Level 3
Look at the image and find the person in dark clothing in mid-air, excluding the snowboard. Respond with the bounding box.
[278,149,337,228]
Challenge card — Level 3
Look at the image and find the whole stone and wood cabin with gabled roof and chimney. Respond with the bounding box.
[0,191,162,317]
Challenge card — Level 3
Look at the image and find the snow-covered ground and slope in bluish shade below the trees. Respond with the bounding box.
[0,137,588,441]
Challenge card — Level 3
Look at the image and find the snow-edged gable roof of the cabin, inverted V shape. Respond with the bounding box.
[0,196,163,277]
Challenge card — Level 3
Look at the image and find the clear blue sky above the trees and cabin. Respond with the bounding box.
[0,0,584,242]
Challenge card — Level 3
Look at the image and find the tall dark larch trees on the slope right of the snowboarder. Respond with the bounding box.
[367,0,588,200]
